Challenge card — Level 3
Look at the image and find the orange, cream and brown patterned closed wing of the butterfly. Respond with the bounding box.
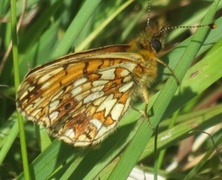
[17,49,141,146]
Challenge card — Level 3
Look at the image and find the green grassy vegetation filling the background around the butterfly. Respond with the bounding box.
[0,0,222,179]
